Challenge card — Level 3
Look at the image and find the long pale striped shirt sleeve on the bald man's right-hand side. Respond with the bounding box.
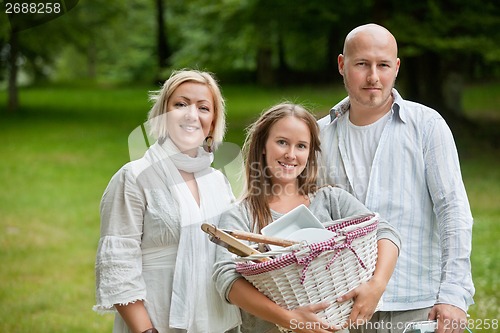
[424,118,475,311]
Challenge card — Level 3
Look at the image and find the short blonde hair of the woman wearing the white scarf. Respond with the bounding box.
[148,69,226,144]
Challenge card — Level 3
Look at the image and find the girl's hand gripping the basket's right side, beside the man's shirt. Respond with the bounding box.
[337,278,385,327]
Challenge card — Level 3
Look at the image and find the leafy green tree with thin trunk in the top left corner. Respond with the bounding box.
[0,0,127,112]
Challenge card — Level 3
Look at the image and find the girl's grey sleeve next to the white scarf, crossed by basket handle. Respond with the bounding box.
[213,203,250,303]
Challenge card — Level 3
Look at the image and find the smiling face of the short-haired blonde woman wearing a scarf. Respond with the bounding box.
[167,82,215,154]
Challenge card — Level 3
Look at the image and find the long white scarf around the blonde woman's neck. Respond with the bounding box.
[146,139,241,333]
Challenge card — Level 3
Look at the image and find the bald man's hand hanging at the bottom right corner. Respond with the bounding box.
[429,304,467,333]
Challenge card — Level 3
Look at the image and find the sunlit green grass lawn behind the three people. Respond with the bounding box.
[0,84,500,333]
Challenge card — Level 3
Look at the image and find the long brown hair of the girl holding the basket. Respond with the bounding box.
[243,102,321,231]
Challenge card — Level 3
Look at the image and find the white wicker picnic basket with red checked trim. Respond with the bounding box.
[235,214,379,332]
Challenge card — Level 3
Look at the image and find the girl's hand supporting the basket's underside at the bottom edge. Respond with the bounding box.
[286,302,342,333]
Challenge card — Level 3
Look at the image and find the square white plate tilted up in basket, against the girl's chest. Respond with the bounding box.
[261,205,325,250]
